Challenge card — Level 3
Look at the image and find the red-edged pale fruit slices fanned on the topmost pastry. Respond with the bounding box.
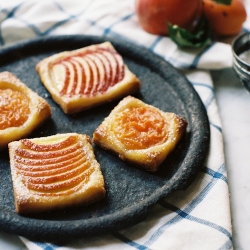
[50,48,124,96]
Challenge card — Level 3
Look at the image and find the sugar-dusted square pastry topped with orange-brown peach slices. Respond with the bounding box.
[9,133,106,214]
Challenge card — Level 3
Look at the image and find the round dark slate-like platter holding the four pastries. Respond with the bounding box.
[0,35,210,241]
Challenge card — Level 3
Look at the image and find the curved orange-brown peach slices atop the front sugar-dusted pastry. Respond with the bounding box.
[14,136,93,196]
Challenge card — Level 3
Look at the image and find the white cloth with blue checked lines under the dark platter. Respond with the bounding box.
[0,0,238,250]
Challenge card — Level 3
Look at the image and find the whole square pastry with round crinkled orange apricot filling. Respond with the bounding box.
[93,96,187,172]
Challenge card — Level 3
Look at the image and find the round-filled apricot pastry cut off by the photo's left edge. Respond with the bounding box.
[0,72,51,150]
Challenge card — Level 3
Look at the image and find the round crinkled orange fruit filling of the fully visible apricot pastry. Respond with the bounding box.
[112,107,168,150]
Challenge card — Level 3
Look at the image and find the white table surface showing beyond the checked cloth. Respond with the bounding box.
[0,69,250,250]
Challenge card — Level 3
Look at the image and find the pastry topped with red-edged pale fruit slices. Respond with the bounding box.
[36,42,140,114]
